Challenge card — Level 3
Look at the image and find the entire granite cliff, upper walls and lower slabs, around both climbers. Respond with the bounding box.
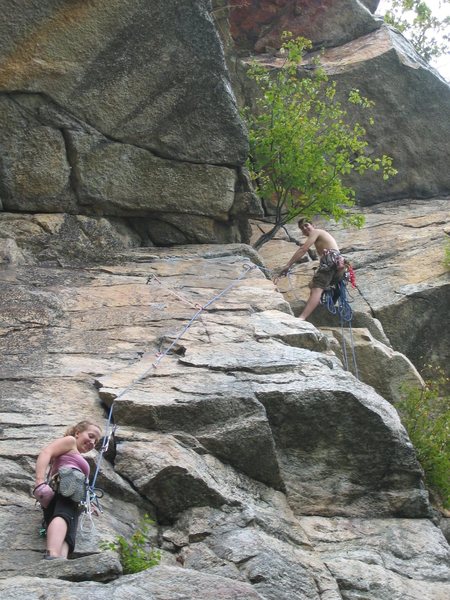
[0,0,450,600]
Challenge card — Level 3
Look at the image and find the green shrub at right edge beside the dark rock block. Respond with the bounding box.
[397,368,450,509]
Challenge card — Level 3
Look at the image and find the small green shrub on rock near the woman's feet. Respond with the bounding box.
[100,515,161,575]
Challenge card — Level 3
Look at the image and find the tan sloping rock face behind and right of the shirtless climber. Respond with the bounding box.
[261,198,450,376]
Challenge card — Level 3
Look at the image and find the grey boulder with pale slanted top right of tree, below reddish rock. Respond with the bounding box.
[240,26,450,206]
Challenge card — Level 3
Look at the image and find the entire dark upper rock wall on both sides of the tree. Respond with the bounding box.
[0,0,450,244]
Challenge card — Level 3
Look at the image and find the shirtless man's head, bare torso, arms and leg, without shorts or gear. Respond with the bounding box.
[279,219,345,321]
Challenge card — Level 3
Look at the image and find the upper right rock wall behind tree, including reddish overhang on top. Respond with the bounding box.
[231,0,450,205]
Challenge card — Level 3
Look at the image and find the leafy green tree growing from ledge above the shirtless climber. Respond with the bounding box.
[244,33,397,248]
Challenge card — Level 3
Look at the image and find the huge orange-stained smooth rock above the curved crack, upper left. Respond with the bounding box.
[0,0,246,164]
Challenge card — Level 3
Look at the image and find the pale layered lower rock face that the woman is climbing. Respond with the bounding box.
[0,245,449,600]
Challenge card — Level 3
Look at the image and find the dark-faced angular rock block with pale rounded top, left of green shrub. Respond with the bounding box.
[255,370,429,517]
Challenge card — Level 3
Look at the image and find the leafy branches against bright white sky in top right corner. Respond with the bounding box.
[384,0,450,62]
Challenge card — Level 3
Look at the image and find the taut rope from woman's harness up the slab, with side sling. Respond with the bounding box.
[80,263,261,533]
